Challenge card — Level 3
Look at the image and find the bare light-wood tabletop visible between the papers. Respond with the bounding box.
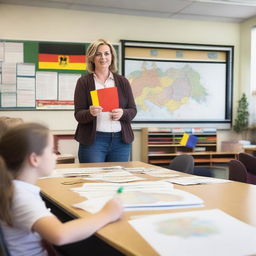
[38,162,256,256]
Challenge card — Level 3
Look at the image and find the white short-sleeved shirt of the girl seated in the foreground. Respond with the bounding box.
[1,180,52,256]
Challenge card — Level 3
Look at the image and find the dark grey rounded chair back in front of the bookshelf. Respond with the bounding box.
[168,154,194,174]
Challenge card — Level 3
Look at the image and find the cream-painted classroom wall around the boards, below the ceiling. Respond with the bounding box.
[0,4,246,160]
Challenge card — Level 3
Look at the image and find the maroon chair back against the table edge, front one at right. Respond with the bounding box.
[228,160,247,183]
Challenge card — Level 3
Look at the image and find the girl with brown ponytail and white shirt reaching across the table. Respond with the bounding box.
[0,123,123,256]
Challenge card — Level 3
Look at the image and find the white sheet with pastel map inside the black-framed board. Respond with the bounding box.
[125,60,225,120]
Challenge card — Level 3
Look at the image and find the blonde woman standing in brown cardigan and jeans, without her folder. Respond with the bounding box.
[74,39,137,163]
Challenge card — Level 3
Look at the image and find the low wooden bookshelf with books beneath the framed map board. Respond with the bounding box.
[141,128,237,167]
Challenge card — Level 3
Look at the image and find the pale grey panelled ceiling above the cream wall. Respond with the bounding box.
[0,0,256,22]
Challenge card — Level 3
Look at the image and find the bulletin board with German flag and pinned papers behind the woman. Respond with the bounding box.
[0,40,120,110]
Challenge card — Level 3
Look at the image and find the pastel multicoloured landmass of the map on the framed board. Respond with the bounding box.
[128,62,207,111]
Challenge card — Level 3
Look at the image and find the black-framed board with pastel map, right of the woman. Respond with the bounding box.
[122,40,234,128]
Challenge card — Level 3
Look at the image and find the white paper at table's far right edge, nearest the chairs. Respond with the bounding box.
[165,176,231,186]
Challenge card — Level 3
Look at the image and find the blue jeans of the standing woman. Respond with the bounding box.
[78,132,131,163]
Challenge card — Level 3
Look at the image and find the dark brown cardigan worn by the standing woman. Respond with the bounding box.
[74,73,137,145]
